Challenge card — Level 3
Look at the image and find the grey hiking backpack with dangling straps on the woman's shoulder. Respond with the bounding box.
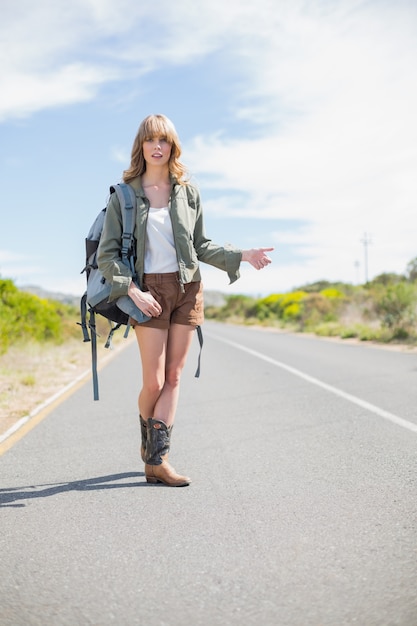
[79,183,203,400]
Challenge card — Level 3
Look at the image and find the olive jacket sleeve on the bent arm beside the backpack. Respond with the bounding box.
[97,193,132,301]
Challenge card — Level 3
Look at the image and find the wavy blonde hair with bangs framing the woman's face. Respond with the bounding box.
[123,114,187,185]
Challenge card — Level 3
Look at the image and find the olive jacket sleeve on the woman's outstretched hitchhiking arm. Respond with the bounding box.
[192,187,242,283]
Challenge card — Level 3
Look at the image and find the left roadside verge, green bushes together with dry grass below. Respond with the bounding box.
[0,278,128,428]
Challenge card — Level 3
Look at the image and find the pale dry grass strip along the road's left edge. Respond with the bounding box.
[0,331,135,435]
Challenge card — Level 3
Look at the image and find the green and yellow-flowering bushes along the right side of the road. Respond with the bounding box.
[205,258,417,345]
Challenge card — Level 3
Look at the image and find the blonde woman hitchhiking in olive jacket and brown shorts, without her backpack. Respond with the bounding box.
[98,115,273,487]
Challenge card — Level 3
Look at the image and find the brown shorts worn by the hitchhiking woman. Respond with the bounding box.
[130,272,204,328]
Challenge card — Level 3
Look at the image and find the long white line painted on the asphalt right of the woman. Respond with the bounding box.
[210,334,417,433]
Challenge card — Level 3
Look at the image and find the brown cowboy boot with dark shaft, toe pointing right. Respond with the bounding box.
[145,418,191,487]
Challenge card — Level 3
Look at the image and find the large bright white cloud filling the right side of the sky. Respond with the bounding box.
[183,2,417,282]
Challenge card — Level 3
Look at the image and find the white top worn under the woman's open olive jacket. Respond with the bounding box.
[145,207,178,274]
